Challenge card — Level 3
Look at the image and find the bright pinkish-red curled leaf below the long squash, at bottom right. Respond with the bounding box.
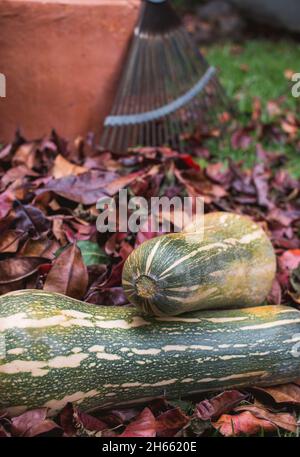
[212,411,277,436]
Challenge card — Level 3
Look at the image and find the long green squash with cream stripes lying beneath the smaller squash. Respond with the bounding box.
[0,291,300,414]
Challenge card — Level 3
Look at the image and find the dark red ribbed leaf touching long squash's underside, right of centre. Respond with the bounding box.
[195,390,247,421]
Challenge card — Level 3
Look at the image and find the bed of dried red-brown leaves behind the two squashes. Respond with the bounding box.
[0,125,300,305]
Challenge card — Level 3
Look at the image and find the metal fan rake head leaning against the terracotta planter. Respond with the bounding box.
[100,0,228,153]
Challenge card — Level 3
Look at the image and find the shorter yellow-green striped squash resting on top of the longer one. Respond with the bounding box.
[123,213,276,316]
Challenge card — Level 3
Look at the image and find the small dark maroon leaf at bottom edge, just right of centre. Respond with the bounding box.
[156,408,191,437]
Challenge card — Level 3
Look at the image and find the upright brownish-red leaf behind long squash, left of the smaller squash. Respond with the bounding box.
[44,244,89,300]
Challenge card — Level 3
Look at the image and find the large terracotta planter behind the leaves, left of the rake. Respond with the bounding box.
[0,0,140,142]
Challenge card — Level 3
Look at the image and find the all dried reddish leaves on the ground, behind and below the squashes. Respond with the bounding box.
[0,93,300,437]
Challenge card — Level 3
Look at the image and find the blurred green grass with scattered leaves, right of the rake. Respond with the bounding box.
[205,40,300,177]
